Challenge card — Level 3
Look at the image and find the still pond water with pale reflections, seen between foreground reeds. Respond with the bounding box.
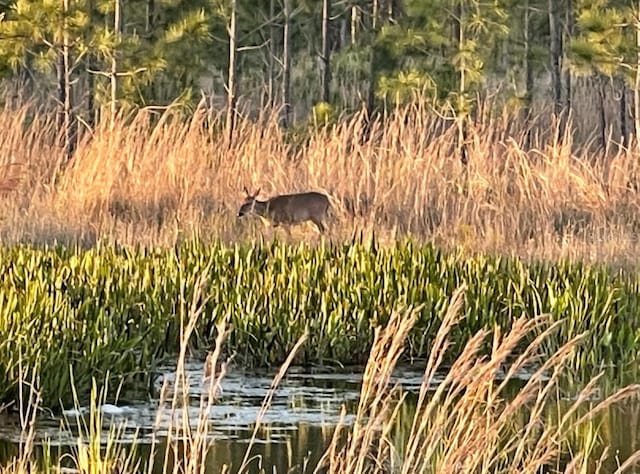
[0,362,640,474]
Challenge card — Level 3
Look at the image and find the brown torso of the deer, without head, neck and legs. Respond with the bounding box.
[267,192,329,223]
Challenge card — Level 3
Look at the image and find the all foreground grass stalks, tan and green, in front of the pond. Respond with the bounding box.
[2,286,640,474]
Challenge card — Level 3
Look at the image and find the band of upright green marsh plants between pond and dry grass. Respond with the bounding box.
[0,241,640,408]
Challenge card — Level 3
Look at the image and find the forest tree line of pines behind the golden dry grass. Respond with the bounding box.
[0,0,640,160]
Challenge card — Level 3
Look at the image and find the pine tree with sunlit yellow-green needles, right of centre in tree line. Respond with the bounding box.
[374,0,509,163]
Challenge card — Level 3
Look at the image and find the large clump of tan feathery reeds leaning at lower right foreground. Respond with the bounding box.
[316,289,640,474]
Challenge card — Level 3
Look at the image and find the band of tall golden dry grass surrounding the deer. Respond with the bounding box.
[0,99,640,259]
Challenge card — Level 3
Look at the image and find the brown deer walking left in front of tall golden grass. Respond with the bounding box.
[238,187,330,234]
